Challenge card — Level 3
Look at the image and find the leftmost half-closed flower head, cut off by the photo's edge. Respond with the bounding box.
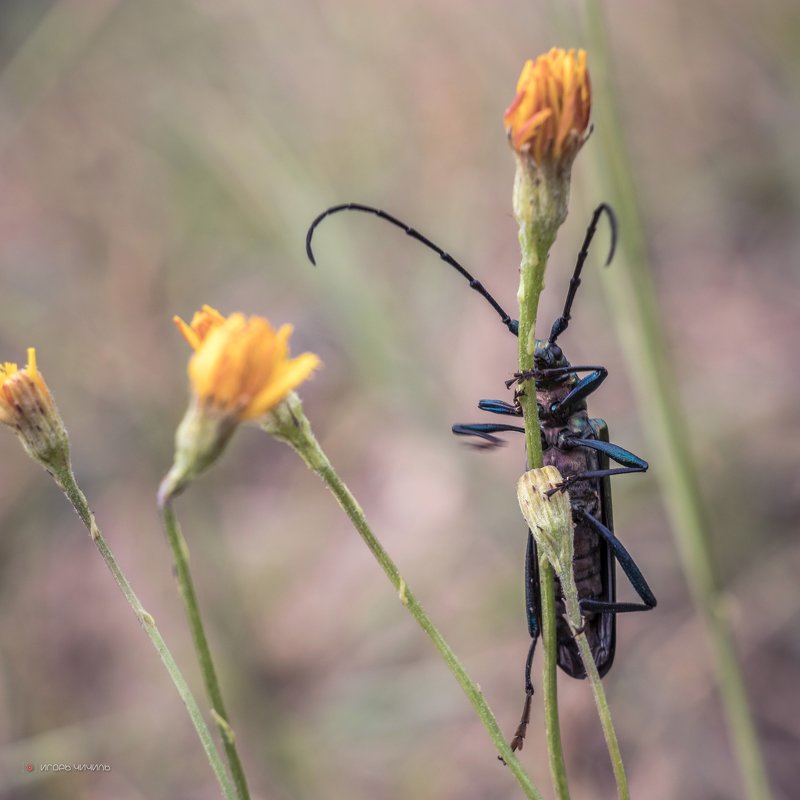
[0,347,69,473]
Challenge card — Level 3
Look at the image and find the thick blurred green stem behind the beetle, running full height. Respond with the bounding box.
[586,2,772,800]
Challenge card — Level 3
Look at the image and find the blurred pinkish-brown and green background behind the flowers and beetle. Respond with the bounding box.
[0,0,800,800]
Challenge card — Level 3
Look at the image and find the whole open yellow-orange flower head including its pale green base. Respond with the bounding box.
[159,306,320,505]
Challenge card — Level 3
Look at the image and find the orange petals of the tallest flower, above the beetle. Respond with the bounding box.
[503,47,592,164]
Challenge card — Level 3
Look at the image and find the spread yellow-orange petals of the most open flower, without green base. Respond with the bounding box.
[175,306,320,421]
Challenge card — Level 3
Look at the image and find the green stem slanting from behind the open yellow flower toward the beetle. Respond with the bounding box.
[263,392,542,800]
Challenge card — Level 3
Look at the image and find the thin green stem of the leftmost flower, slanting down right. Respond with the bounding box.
[52,465,237,800]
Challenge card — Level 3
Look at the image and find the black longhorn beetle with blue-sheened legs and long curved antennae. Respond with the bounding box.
[306,203,656,750]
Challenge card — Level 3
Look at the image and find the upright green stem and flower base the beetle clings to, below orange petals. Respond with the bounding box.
[514,156,569,800]
